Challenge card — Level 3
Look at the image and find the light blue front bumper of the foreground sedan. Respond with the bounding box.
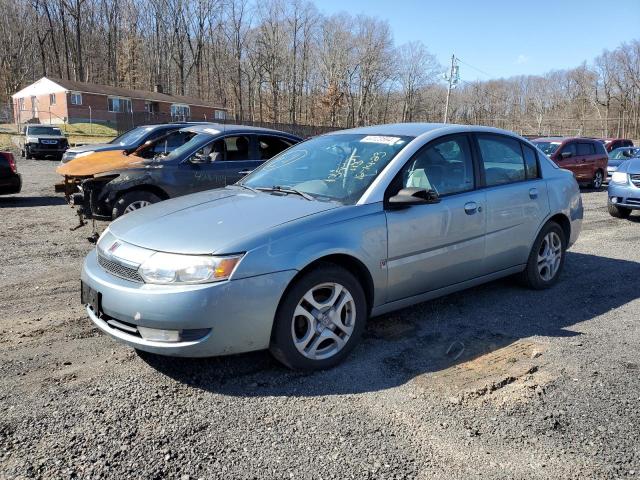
[81,250,297,357]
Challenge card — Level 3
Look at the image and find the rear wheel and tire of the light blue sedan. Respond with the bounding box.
[520,221,567,290]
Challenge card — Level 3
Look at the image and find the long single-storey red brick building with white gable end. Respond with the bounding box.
[12,77,227,130]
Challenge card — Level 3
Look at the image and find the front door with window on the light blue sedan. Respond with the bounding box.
[386,135,486,301]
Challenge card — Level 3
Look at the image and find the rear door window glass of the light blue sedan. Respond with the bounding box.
[478,135,527,186]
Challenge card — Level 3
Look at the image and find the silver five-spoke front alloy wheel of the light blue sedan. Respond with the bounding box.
[291,282,356,360]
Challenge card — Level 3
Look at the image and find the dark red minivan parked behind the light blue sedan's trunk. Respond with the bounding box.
[532,137,609,188]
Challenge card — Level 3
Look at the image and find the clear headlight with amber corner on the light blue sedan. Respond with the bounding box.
[138,252,243,284]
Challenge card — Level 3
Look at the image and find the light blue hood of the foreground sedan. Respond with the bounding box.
[109,187,341,254]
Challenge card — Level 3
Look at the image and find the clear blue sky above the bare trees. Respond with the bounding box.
[315,0,640,81]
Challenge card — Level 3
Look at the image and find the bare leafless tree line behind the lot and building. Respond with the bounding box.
[0,0,640,138]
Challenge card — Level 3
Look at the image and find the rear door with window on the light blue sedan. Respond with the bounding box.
[476,133,549,274]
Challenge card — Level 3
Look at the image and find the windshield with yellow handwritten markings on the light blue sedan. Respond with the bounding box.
[242,134,413,204]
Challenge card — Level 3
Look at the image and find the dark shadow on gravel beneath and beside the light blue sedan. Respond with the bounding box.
[140,252,640,396]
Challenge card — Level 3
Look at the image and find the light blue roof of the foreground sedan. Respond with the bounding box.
[325,123,522,138]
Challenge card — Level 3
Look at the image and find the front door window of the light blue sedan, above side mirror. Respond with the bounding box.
[401,136,475,196]
